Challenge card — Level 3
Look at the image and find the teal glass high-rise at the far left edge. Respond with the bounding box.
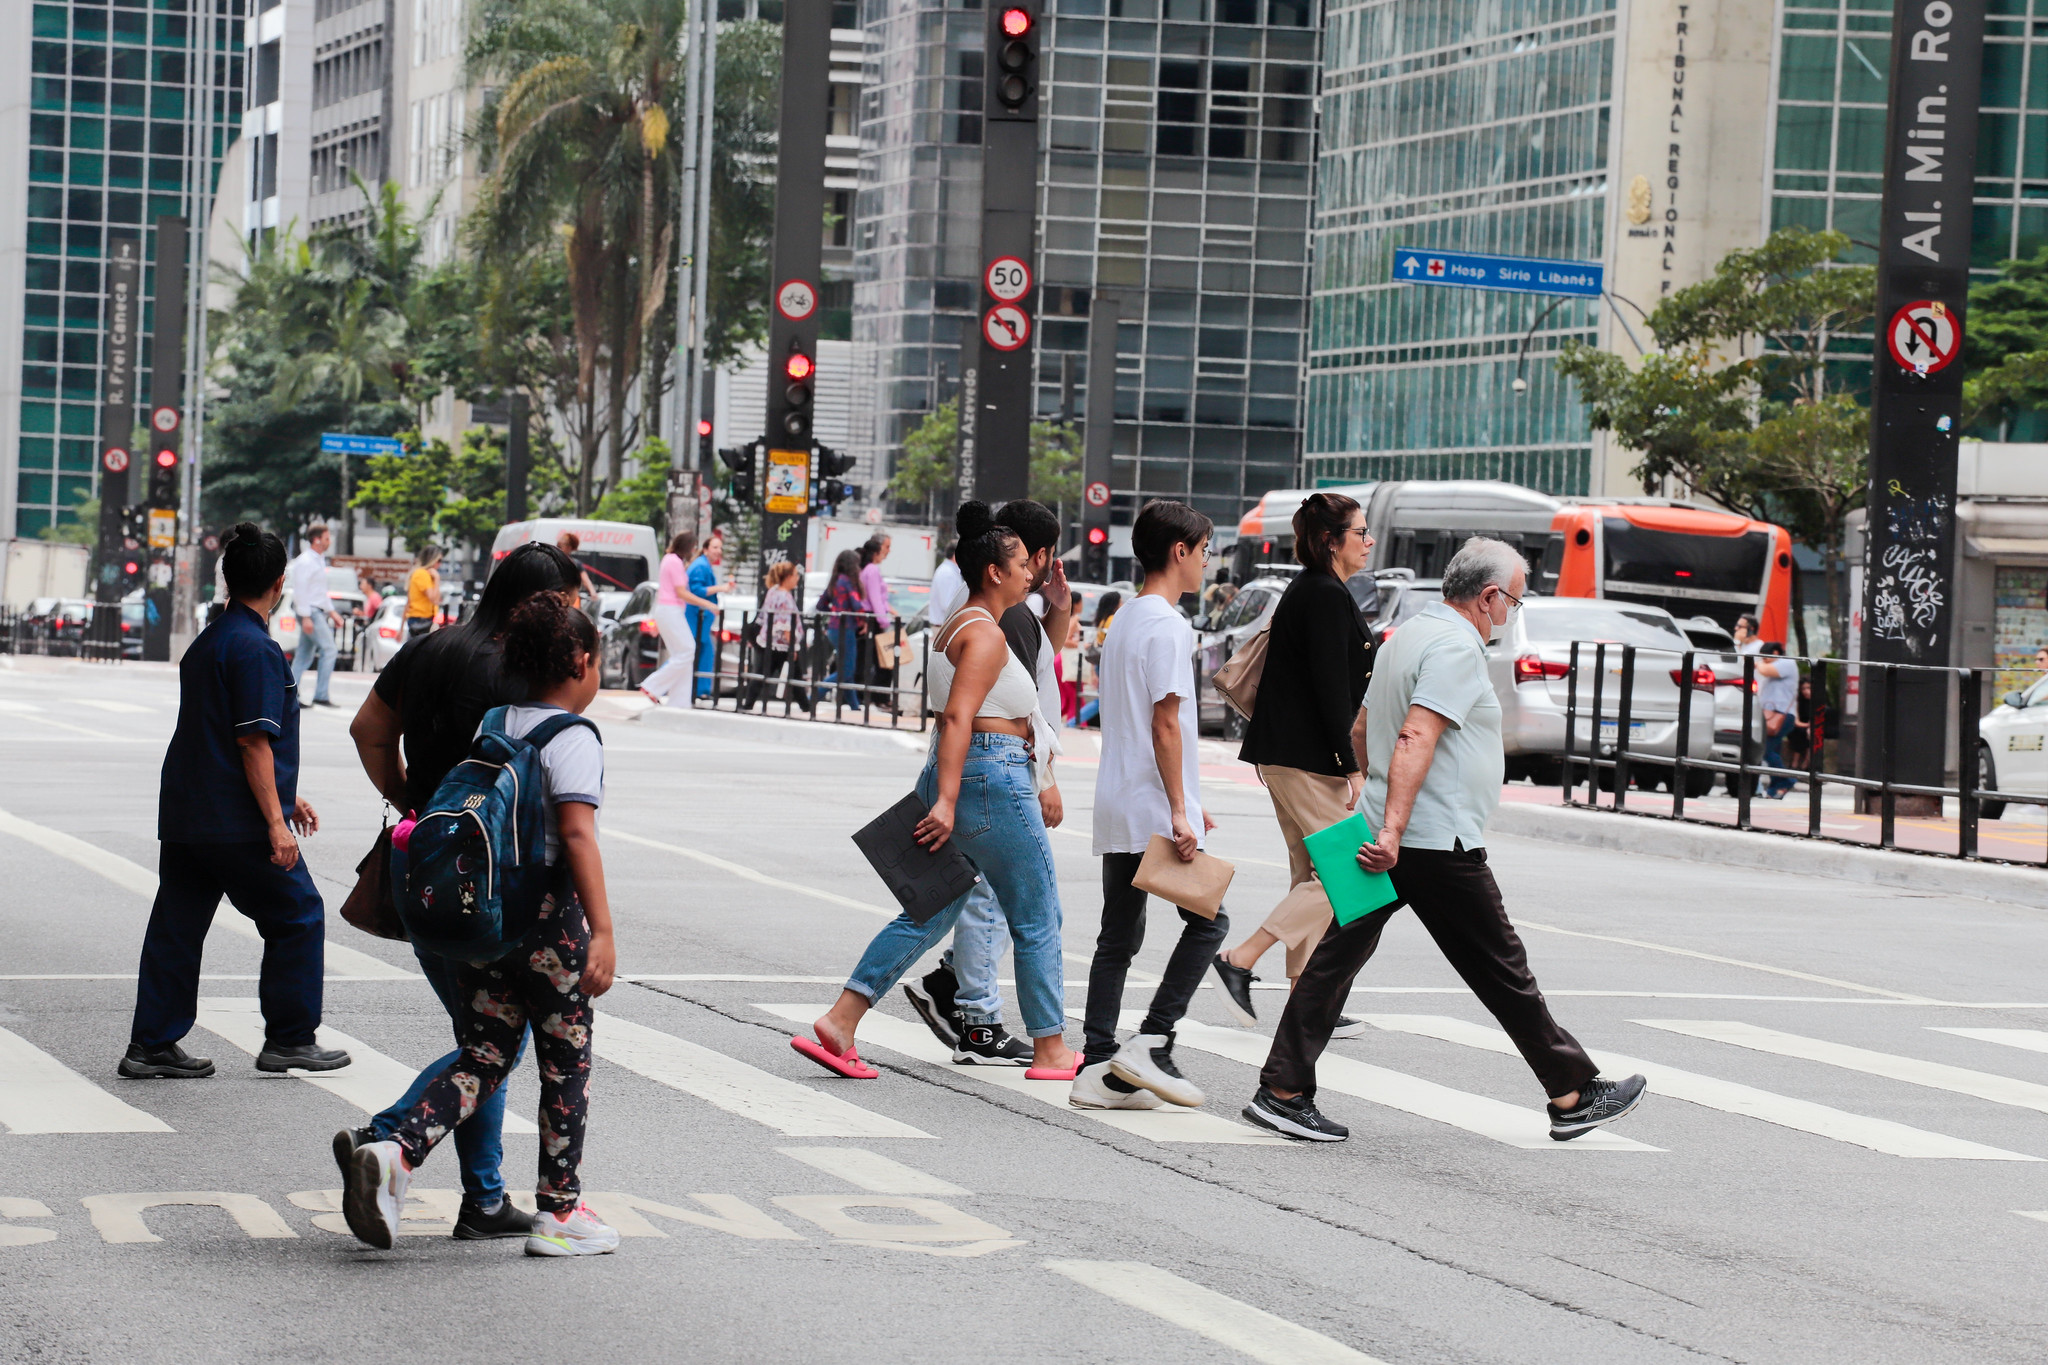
[0,0,244,536]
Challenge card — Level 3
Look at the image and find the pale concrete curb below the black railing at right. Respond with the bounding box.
[1487,802,2048,911]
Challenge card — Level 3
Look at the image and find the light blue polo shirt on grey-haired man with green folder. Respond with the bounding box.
[1364,602,1507,851]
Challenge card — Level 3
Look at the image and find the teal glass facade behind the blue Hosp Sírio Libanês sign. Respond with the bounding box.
[1305,0,1614,493]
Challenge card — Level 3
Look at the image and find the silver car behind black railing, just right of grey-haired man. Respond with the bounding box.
[1487,598,1716,796]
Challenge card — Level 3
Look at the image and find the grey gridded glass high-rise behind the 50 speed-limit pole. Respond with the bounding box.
[854,0,1317,540]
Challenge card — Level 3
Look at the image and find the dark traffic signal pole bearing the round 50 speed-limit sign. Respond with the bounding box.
[961,0,1042,503]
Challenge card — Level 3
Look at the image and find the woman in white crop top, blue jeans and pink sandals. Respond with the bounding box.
[791,501,1079,1081]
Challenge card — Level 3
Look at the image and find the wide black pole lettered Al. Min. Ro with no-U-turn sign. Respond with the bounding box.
[1855,0,1985,814]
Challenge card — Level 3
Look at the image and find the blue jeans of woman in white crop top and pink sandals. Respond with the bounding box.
[846,735,1067,1038]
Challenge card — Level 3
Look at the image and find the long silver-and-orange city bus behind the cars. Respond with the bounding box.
[1231,479,1792,641]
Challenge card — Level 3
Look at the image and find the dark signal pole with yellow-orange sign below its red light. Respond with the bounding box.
[760,0,831,571]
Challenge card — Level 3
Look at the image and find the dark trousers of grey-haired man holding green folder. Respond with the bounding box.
[1260,849,1599,1097]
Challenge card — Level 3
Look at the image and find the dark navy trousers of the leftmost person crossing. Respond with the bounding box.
[129,843,328,1048]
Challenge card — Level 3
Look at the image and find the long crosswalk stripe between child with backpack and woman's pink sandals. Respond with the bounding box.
[590,1015,932,1138]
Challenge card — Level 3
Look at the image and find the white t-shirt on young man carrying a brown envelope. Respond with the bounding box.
[1096,598,1204,855]
